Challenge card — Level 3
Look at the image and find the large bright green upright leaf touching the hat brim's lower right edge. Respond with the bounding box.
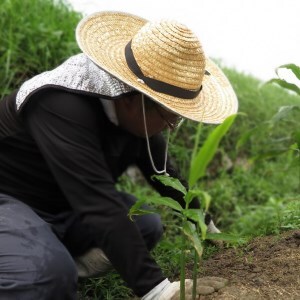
[189,114,236,187]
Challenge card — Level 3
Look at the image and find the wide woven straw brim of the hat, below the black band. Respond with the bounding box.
[76,11,238,124]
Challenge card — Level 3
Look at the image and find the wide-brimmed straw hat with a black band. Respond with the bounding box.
[76,11,238,124]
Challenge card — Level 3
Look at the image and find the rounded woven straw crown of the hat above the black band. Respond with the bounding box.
[131,21,206,90]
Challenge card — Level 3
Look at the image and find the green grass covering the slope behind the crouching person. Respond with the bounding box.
[0,0,300,299]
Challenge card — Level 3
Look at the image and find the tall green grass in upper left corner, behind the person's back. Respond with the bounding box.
[0,0,81,98]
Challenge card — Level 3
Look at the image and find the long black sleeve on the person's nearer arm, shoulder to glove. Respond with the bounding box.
[24,90,164,284]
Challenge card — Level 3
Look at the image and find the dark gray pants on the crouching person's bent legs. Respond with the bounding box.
[0,194,162,300]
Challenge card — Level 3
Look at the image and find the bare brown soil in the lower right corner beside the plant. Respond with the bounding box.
[195,230,300,300]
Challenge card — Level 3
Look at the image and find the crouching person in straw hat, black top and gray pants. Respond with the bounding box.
[0,11,238,300]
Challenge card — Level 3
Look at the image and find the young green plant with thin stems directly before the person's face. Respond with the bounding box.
[129,115,236,300]
